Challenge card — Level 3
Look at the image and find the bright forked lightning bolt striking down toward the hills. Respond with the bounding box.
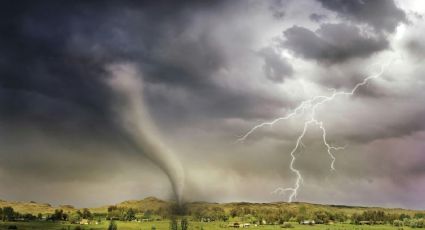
[237,59,395,202]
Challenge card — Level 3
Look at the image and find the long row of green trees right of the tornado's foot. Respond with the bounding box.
[188,206,425,228]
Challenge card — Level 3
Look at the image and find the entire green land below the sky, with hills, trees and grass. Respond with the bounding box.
[0,197,425,230]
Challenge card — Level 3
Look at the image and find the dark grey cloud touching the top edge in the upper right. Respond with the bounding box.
[319,0,407,32]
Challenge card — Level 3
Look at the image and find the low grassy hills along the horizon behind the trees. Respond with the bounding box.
[0,197,425,215]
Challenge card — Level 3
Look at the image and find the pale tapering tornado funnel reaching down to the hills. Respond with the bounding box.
[107,64,184,204]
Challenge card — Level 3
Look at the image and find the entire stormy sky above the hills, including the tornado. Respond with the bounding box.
[0,0,425,209]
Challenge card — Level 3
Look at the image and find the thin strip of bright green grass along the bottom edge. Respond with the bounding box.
[0,221,411,230]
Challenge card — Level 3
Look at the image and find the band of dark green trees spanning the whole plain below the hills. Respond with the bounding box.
[0,202,425,229]
